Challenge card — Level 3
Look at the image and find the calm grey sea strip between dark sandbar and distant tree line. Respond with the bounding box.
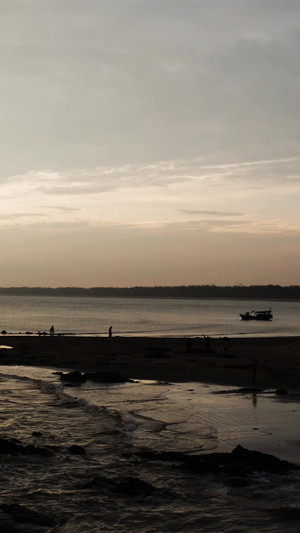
[0,296,300,336]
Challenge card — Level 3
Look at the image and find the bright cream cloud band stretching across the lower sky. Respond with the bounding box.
[0,157,300,235]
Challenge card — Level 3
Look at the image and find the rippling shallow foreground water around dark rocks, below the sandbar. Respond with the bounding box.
[0,366,300,533]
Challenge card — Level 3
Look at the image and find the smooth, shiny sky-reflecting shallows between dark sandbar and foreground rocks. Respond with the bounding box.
[0,366,300,464]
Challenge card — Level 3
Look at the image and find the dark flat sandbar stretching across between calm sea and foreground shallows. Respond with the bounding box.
[0,335,300,391]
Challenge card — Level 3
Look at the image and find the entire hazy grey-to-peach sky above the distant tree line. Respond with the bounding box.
[0,0,300,287]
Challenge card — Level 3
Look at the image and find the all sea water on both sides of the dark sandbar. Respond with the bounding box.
[0,296,300,533]
